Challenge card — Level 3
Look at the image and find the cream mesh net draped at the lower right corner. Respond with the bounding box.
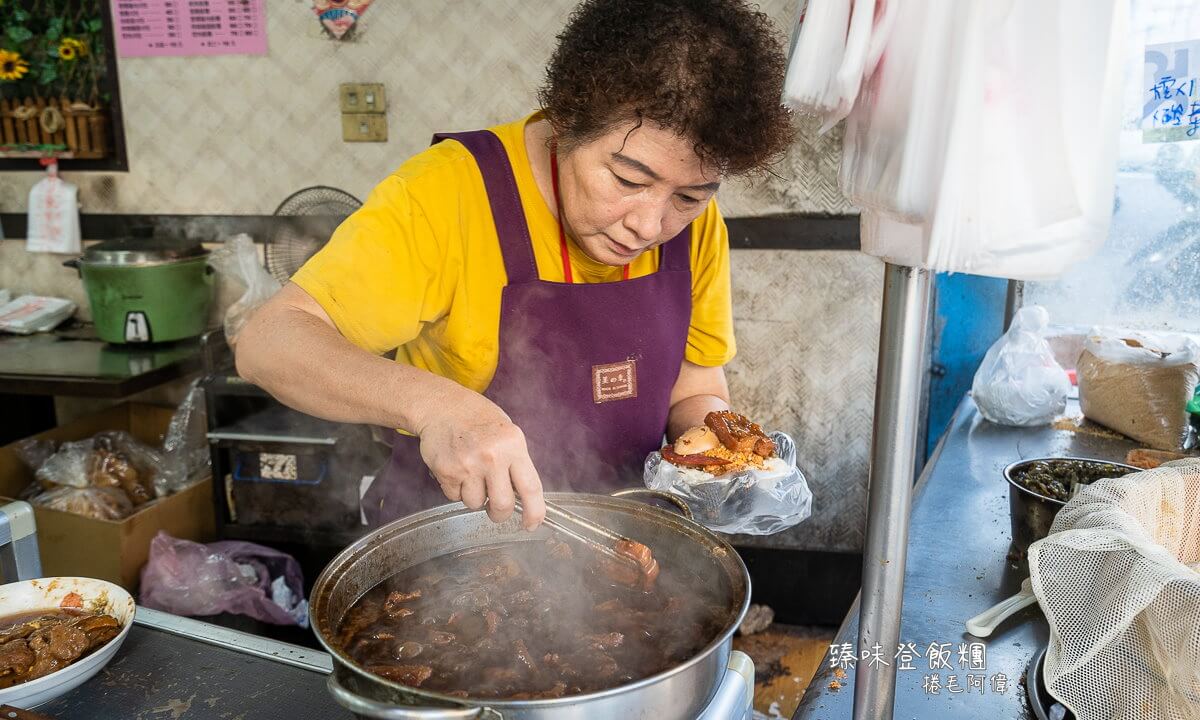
[1030,460,1200,720]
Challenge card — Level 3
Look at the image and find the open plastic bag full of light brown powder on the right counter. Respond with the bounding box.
[1076,332,1200,452]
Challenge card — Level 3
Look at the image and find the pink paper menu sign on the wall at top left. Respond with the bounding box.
[113,0,266,58]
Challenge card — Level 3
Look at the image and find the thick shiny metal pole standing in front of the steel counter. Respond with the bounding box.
[854,263,931,720]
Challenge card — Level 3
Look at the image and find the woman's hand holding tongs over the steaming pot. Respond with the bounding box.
[418,389,546,530]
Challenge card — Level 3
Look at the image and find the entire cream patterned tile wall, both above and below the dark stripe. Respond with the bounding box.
[0,0,882,551]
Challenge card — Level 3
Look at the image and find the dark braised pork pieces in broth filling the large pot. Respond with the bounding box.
[336,540,730,700]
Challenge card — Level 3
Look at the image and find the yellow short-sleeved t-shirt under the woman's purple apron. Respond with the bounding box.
[292,114,736,392]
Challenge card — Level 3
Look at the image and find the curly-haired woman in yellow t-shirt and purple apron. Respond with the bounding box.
[236,0,791,528]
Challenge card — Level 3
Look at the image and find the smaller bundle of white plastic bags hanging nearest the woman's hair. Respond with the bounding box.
[784,0,896,132]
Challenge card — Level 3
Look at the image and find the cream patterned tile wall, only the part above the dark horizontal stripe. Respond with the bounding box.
[0,0,848,216]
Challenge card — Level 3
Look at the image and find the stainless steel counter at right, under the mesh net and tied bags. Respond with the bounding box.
[793,397,1136,720]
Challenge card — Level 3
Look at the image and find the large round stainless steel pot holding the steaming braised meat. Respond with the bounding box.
[310,491,750,720]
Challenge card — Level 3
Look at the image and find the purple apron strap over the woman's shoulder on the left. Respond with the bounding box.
[431,130,538,284]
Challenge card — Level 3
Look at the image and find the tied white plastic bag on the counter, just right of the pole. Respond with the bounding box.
[971,305,1070,426]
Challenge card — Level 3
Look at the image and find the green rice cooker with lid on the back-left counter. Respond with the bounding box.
[65,236,212,343]
